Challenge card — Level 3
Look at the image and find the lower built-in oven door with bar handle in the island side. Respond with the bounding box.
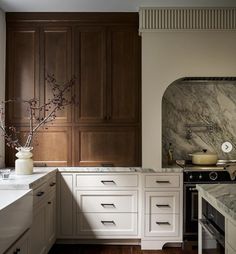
[199,218,225,254]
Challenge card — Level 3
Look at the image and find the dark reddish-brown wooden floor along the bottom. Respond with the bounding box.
[49,244,197,254]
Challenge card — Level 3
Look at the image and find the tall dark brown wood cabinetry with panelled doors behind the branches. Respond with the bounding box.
[6,13,141,166]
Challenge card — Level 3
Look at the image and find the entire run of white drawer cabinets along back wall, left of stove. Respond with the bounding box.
[57,172,183,249]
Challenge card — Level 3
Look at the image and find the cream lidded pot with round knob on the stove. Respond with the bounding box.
[189,149,218,165]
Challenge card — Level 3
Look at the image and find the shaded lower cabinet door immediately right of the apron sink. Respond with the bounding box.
[30,204,46,254]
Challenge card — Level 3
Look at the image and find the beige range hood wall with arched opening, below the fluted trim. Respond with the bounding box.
[142,31,236,168]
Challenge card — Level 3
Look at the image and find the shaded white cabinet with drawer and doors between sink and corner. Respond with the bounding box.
[30,177,56,254]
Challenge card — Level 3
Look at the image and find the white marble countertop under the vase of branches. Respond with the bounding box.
[0,167,57,190]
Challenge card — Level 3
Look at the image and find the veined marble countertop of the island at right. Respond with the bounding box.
[197,183,236,222]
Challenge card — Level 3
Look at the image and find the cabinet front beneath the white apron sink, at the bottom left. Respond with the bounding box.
[5,230,32,254]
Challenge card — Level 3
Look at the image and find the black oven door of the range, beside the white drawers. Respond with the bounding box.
[184,183,198,237]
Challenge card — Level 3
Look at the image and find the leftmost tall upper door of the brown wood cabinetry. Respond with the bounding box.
[6,28,39,123]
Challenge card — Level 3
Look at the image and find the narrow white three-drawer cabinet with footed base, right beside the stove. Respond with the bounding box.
[141,173,183,249]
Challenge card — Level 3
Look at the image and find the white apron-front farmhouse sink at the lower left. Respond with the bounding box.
[0,190,33,254]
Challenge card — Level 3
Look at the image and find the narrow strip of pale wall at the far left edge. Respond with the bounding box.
[0,9,6,168]
